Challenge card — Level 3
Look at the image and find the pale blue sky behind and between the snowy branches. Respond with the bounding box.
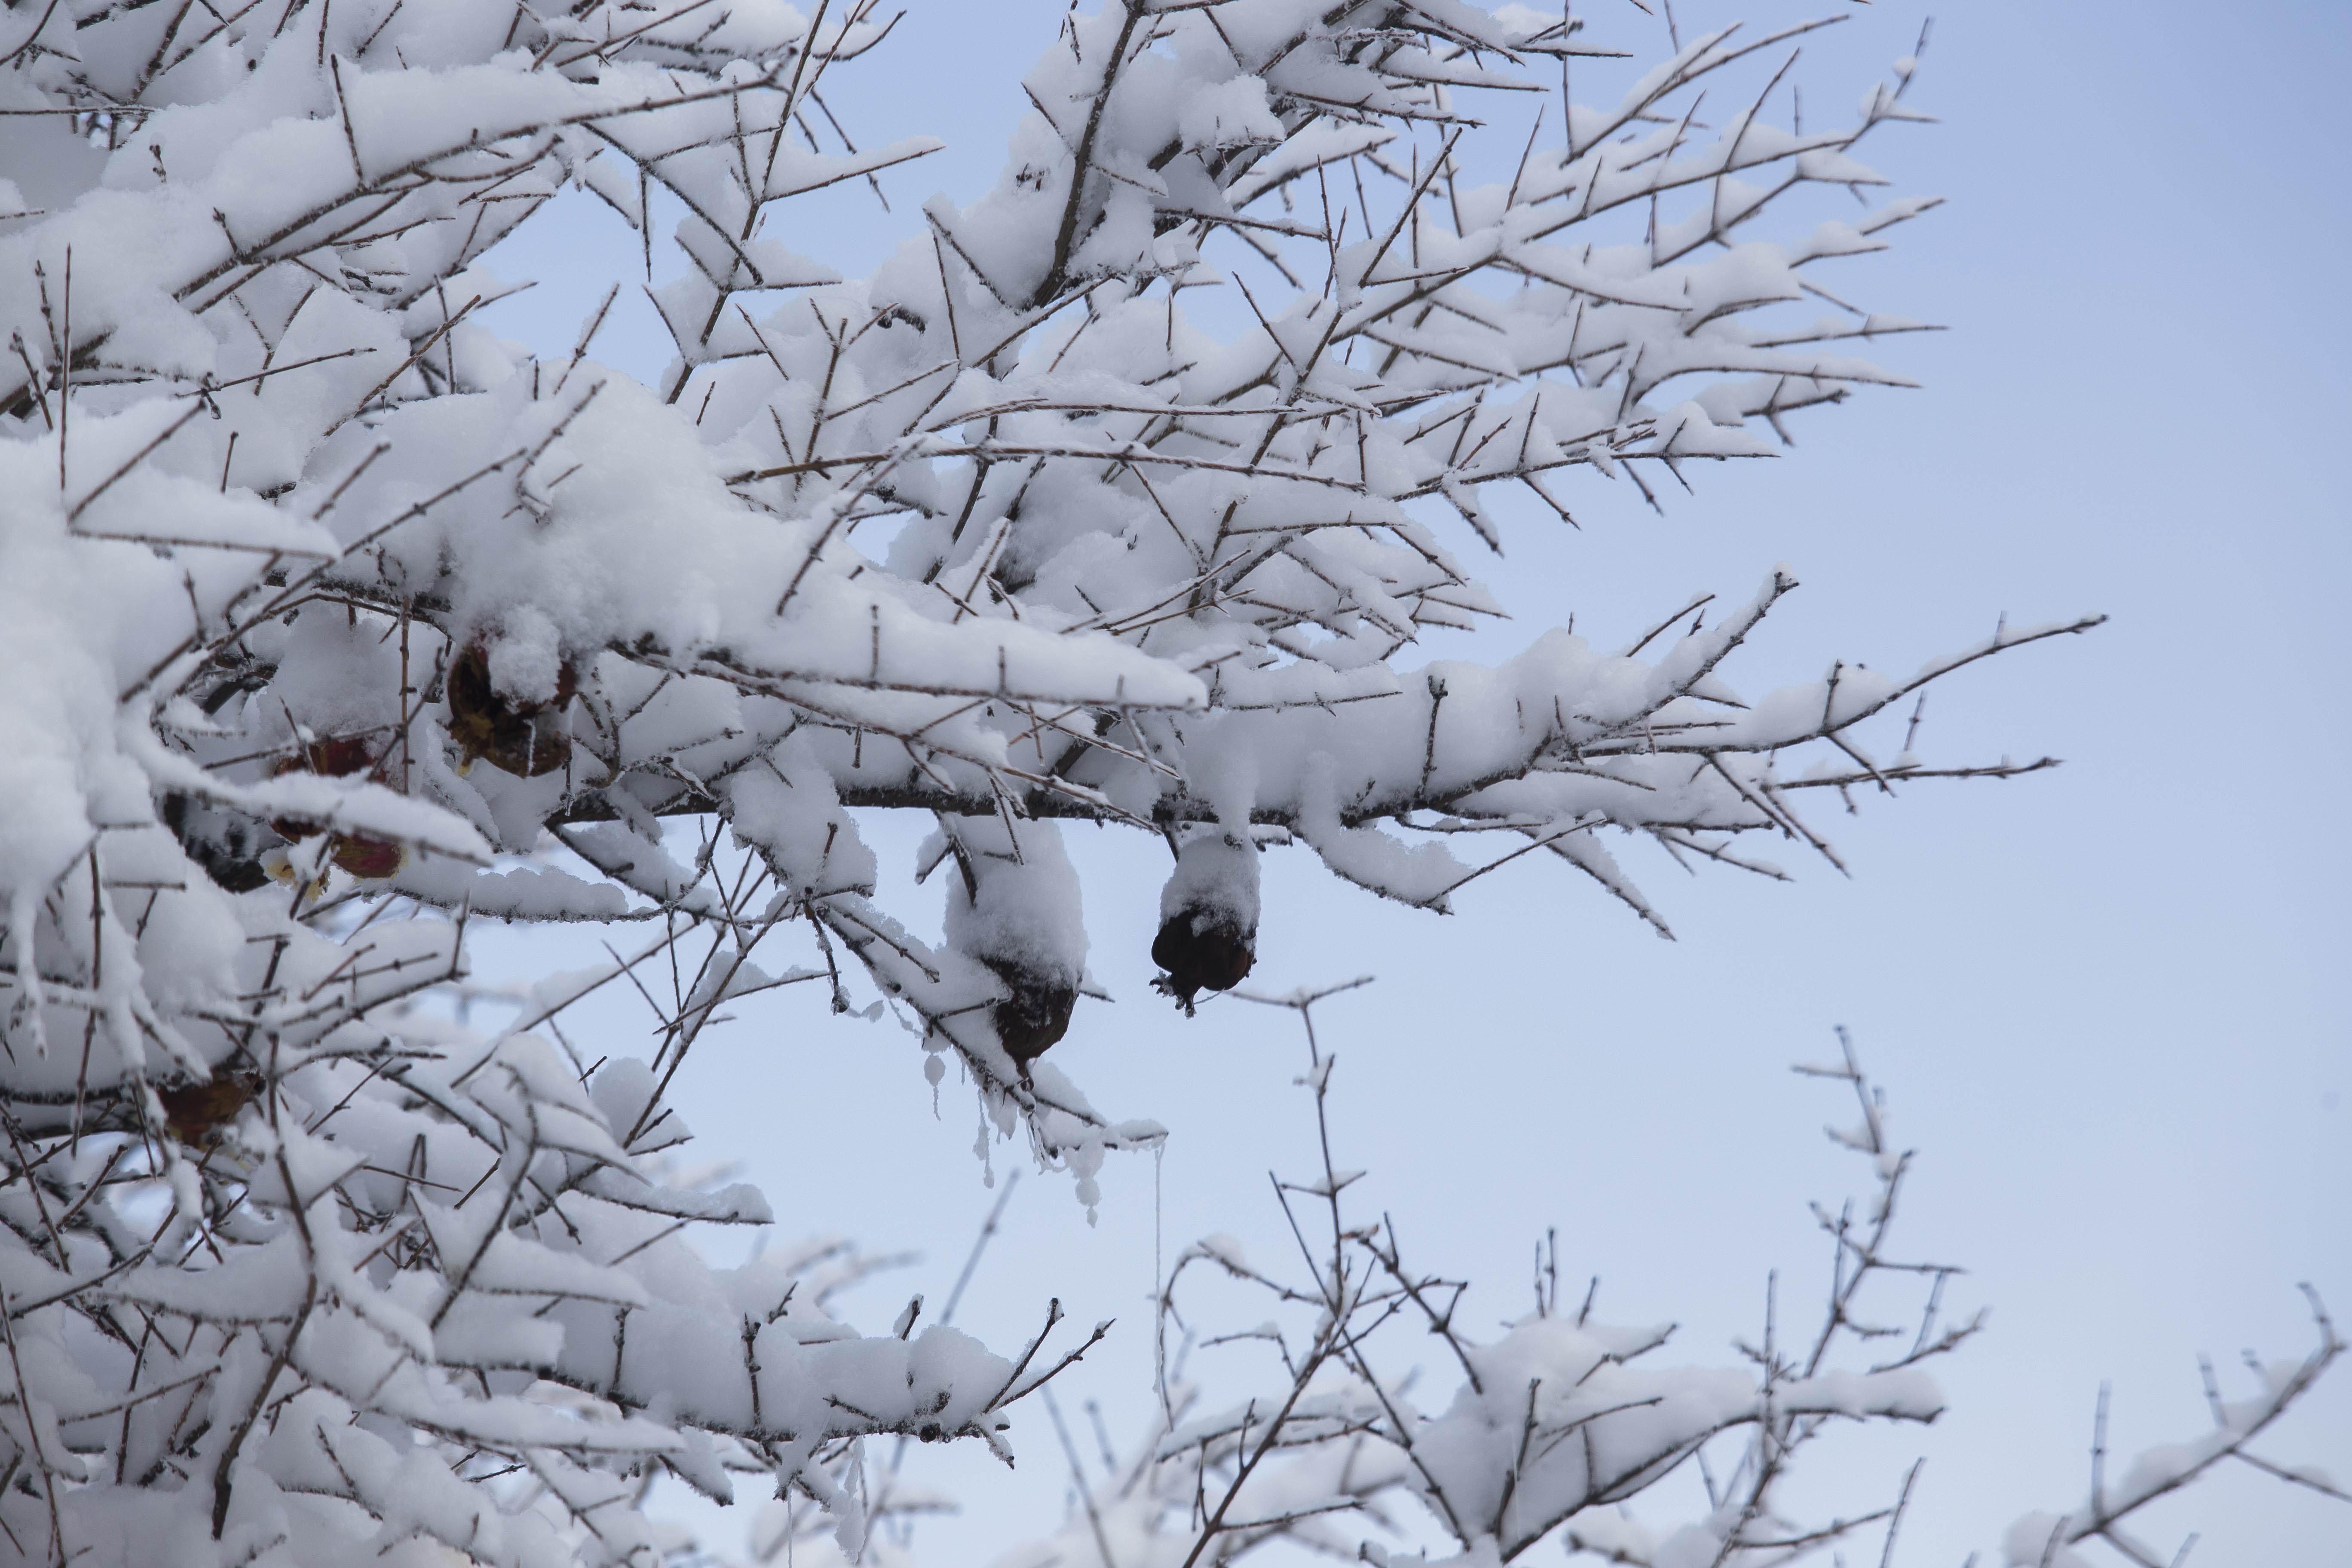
[468,0,2352,1568]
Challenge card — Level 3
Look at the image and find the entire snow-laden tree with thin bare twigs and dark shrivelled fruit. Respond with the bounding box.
[0,0,2336,1568]
